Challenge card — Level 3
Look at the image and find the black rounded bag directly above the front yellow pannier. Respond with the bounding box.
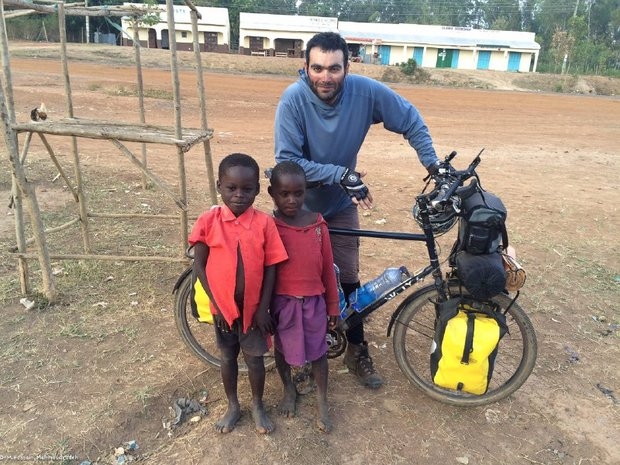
[456,250,506,300]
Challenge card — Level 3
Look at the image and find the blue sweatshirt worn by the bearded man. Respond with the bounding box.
[275,70,437,221]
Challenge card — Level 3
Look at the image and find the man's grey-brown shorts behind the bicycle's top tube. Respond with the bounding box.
[325,205,360,284]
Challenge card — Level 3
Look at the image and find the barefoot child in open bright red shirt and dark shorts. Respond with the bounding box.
[189,153,287,433]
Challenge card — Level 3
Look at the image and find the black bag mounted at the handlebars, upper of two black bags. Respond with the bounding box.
[456,191,508,254]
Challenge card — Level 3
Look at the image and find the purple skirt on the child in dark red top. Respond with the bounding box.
[271,295,327,366]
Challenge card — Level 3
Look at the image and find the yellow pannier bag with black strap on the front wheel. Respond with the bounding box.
[431,299,508,394]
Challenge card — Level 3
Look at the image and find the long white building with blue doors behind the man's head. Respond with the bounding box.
[239,13,540,72]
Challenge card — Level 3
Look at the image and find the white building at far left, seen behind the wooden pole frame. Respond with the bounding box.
[121,3,230,52]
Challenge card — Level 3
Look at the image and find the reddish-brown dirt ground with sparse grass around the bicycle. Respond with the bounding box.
[0,44,620,465]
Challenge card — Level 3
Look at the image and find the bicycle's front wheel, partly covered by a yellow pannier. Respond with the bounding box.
[392,285,537,406]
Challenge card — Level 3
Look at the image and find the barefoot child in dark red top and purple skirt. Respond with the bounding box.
[268,161,339,432]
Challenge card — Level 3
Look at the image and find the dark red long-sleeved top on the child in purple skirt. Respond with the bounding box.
[274,214,340,315]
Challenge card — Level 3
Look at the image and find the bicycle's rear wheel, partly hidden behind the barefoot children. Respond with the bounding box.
[174,273,276,372]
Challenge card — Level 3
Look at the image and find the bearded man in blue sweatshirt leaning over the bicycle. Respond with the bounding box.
[275,32,439,389]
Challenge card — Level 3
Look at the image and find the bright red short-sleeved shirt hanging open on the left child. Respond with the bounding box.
[189,205,287,332]
